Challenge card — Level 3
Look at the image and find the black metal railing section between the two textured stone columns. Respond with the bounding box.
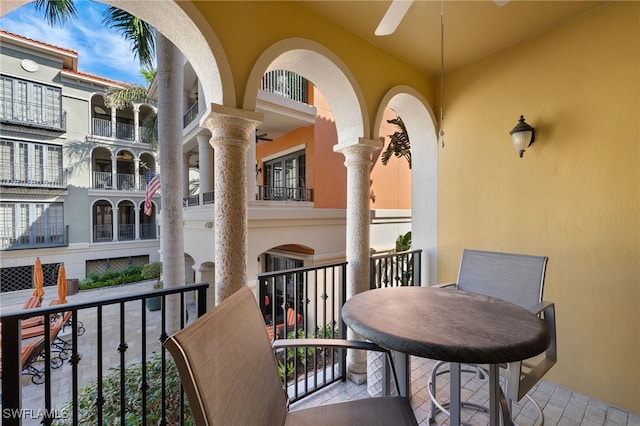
[258,262,347,402]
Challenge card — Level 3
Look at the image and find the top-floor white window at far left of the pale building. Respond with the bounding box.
[0,76,64,129]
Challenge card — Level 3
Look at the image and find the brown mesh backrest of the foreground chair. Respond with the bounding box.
[164,287,287,425]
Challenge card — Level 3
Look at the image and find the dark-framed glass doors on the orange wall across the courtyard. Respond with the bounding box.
[264,151,308,201]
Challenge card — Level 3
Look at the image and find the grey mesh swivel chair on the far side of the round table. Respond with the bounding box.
[428,249,557,424]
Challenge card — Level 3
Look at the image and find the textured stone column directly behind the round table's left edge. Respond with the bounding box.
[334,138,382,384]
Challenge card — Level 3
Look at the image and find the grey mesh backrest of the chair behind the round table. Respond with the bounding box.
[457,249,548,308]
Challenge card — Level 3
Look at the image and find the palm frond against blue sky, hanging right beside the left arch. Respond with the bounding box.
[102,6,155,68]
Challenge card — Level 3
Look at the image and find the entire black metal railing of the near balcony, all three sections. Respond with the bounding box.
[0,251,420,426]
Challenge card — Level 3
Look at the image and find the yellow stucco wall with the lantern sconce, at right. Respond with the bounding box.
[438,2,640,412]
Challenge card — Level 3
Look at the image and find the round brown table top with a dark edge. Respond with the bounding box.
[342,287,550,364]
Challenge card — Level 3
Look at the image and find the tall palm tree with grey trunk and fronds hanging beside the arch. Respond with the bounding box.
[36,0,185,331]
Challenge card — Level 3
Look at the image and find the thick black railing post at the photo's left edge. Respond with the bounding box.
[2,318,22,426]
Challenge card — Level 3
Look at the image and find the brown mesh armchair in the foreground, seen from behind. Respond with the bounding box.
[164,287,417,425]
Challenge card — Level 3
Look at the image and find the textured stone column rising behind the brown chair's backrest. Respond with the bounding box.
[200,104,262,304]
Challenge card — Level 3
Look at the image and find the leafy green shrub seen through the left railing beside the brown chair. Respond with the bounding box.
[53,352,195,426]
